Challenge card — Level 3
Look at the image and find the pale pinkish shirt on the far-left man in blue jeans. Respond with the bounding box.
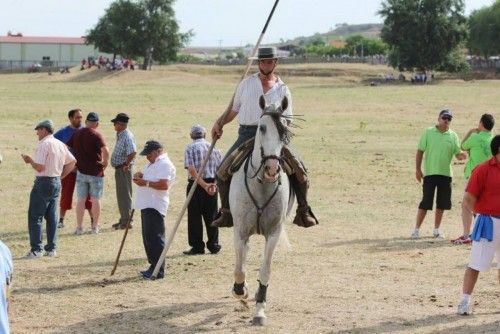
[33,135,76,177]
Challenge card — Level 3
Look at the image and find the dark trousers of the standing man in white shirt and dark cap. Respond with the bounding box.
[141,208,165,274]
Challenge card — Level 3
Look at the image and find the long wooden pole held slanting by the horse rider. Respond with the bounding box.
[151,0,279,278]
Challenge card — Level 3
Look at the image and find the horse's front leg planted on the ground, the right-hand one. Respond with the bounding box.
[253,228,281,326]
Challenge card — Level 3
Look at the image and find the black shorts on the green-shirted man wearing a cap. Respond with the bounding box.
[418,175,451,210]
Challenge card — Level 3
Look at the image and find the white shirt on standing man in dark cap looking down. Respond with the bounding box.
[134,154,175,216]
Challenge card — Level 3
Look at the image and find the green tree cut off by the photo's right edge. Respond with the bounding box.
[468,0,500,58]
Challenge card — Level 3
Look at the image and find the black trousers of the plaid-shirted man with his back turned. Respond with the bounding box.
[186,179,219,251]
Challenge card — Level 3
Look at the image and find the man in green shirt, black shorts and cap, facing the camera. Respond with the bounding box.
[411,109,467,239]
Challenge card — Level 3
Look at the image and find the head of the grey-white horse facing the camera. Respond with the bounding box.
[254,96,290,182]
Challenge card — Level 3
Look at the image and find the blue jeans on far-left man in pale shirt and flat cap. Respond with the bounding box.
[28,176,61,252]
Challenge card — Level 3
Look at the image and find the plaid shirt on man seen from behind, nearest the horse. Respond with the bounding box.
[184,138,222,180]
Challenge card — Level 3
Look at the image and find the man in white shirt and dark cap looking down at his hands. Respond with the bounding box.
[133,140,175,279]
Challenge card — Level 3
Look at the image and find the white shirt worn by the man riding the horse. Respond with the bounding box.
[232,73,293,125]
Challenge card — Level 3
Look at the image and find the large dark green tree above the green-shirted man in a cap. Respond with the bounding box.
[379,0,467,71]
